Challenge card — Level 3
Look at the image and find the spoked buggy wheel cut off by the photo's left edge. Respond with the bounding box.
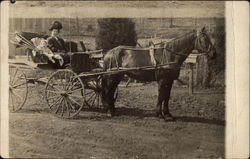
[9,66,28,112]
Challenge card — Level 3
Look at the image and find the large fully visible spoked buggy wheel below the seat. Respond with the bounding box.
[45,70,84,118]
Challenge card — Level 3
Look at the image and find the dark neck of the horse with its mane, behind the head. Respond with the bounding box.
[164,31,195,51]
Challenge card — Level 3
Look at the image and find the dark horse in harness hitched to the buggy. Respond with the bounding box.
[101,27,216,121]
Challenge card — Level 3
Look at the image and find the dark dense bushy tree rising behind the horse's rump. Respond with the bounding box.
[96,18,137,51]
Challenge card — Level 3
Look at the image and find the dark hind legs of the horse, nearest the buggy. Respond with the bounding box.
[102,74,123,116]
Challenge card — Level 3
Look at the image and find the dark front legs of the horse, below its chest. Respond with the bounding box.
[157,79,174,121]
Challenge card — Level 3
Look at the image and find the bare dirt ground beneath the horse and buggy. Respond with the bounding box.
[9,83,225,159]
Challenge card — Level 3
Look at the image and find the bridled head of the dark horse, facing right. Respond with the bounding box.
[194,27,216,59]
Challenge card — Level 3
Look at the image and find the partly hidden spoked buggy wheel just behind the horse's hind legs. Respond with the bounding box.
[83,76,102,108]
